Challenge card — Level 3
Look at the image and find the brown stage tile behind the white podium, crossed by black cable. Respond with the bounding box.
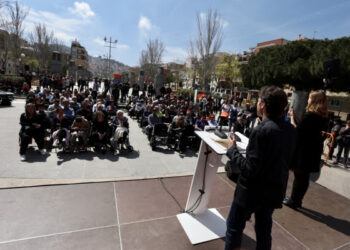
[115,176,233,224]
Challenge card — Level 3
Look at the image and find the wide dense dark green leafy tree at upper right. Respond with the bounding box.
[241,37,350,92]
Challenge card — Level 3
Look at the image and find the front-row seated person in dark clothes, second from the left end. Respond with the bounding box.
[52,107,70,151]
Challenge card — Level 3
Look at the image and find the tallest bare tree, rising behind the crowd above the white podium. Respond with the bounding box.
[190,9,223,91]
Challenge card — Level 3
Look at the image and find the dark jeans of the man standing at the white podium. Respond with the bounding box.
[225,202,274,250]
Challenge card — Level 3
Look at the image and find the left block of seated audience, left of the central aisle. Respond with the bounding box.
[19,85,134,161]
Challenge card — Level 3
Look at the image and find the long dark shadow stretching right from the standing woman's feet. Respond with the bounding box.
[299,208,350,236]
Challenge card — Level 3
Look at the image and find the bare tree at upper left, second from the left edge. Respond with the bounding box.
[30,24,54,71]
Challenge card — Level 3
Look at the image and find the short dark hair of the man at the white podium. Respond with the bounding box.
[259,86,288,118]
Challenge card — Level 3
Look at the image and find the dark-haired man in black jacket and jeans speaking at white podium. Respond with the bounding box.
[225,86,296,250]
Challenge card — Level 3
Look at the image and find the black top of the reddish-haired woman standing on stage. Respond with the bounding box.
[294,112,328,172]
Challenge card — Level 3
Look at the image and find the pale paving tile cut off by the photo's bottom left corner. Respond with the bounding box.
[0,227,121,250]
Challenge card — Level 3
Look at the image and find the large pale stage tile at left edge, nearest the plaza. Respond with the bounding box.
[0,183,117,242]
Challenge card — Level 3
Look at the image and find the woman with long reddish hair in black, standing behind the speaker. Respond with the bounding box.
[283,91,328,209]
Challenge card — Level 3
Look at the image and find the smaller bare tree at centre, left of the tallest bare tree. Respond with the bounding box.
[140,39,165,79]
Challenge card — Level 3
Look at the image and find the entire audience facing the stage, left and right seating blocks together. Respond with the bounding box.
[19,79,260,160]
